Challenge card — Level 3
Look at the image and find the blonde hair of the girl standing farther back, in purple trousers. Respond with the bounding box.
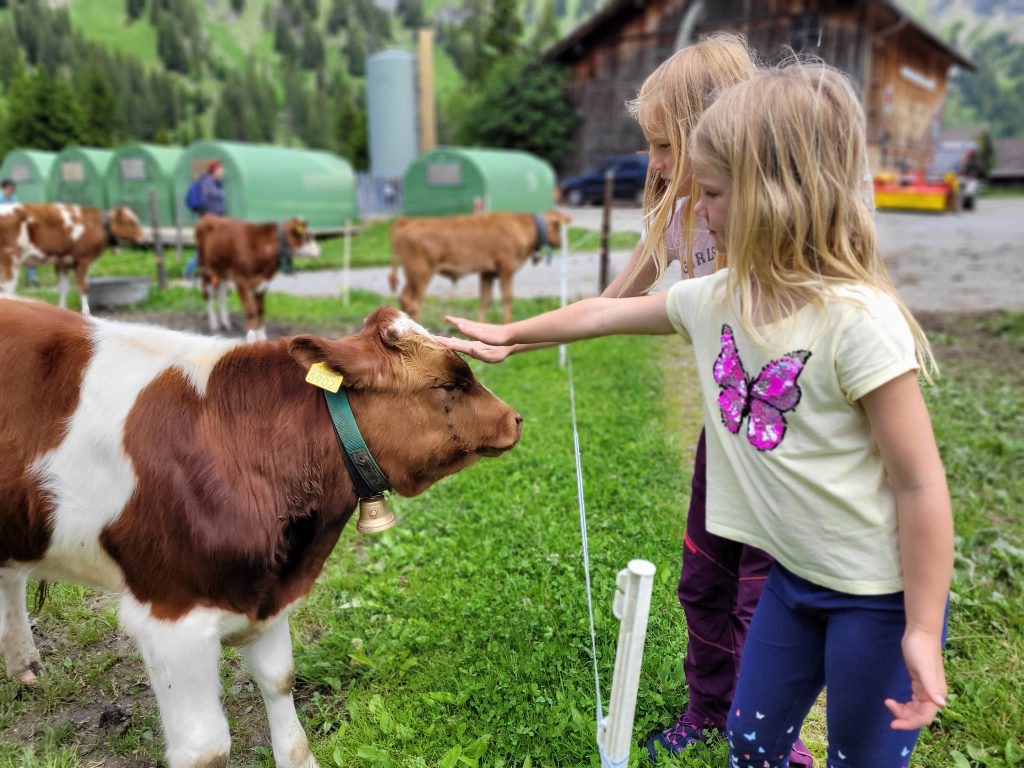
[624,34,757,290]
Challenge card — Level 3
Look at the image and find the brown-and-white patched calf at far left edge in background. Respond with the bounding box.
[0,203,145,314]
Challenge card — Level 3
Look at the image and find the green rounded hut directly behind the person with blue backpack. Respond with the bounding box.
[174,141,356,231]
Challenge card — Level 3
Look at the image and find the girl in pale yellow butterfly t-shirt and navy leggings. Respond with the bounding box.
[440,65,952,768]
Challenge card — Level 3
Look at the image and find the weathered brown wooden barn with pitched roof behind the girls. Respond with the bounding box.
[544,0,974,173]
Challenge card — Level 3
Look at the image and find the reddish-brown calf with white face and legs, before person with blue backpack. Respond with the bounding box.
[196,214,319,341]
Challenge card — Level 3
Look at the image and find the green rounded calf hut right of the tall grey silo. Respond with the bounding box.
[401,146,555,216]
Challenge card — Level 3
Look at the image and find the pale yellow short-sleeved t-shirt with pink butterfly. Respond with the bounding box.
[667,269,918,595]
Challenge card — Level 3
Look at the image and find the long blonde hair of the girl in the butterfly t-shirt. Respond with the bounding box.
[689,61,937,380]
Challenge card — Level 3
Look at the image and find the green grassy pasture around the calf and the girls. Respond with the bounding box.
[0,290,1024,768]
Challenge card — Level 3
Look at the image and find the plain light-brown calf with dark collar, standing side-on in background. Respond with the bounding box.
[388,211,569,323]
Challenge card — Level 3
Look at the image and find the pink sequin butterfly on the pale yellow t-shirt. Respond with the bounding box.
[715,325,811,451]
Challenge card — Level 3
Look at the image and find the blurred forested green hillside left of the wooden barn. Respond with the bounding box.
[0,0,595,168]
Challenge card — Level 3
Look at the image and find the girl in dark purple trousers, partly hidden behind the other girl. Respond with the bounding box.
[452,35,814,768]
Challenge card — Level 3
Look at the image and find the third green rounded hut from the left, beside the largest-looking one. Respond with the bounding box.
[106,144,183,227]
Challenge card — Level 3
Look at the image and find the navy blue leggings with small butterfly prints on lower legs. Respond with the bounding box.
[728,563,937,768]
